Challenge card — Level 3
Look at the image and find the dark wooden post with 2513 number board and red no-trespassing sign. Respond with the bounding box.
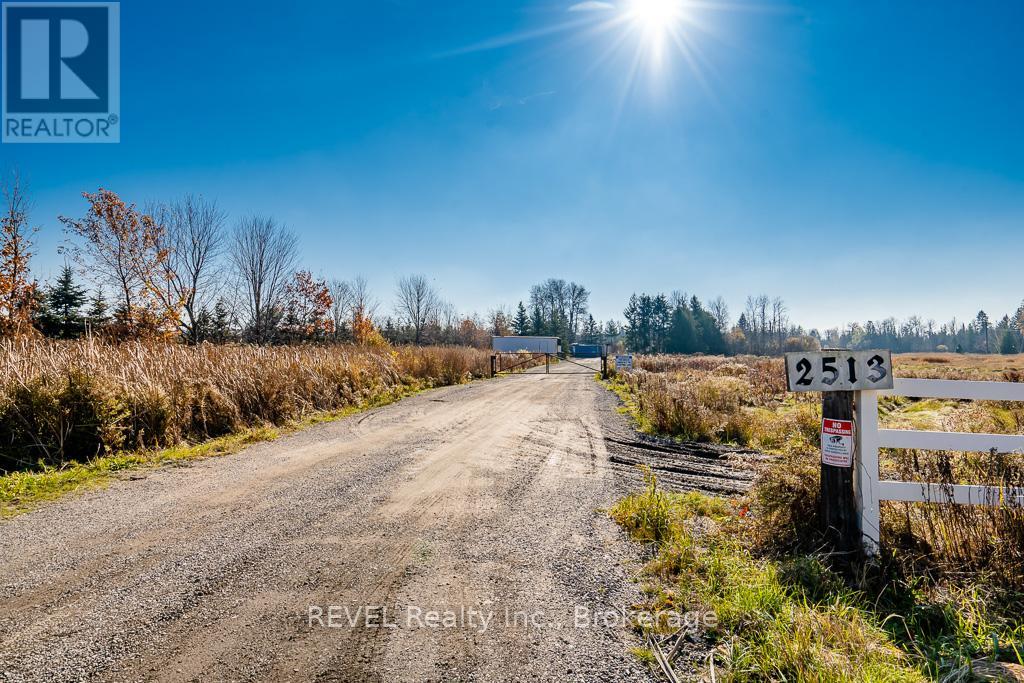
[785,349,893,553]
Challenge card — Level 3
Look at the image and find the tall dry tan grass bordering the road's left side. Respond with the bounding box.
[0,340,489,471]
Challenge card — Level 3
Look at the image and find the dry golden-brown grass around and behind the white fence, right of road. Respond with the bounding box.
[615,354,1024,592]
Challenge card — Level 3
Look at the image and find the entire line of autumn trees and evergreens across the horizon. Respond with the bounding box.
[0,174,1024,355]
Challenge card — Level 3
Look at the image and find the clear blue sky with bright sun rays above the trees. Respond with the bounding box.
[0,0,1024,328]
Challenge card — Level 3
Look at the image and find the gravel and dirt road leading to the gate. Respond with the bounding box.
[0,364,679,681]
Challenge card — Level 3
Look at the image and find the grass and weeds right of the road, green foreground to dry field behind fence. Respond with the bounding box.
[610,354,1024,681]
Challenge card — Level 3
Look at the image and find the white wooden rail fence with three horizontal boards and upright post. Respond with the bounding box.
[854,378,1024,554]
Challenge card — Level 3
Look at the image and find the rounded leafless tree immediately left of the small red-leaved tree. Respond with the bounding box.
[231,216,298,343]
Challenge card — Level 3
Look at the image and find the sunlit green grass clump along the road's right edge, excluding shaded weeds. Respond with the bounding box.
[610,472,927,682]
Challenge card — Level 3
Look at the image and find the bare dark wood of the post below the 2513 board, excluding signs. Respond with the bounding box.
[820,391,860,553]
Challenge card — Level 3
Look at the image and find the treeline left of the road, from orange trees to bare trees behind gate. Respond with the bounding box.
[0,173,598,347]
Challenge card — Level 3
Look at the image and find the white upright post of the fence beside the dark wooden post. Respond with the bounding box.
[854,391,882,556]
